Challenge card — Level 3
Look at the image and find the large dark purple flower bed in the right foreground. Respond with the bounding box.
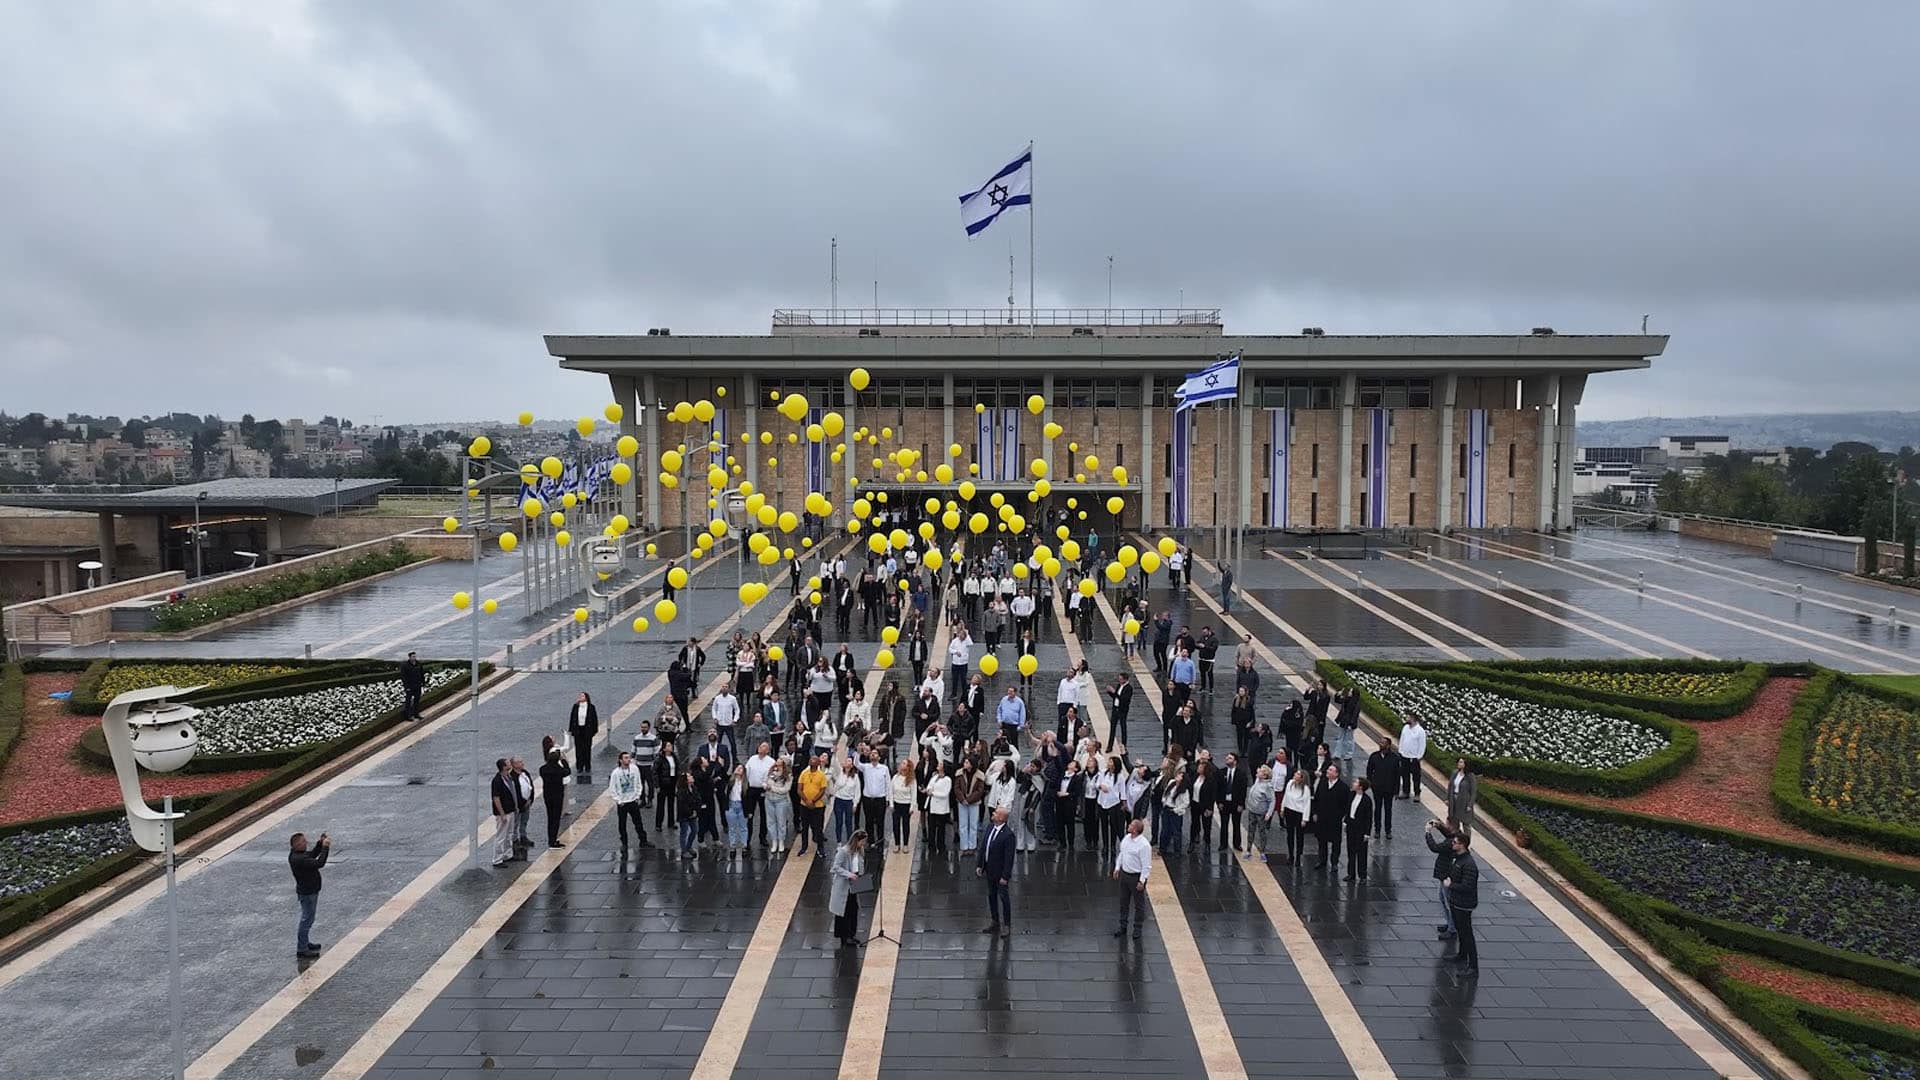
[1515,799,1920,978]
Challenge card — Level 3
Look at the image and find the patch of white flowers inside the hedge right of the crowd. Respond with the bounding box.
[1352,671,1667,769]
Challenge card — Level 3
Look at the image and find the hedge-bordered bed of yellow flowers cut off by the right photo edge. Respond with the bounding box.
[1772,671,1920,855]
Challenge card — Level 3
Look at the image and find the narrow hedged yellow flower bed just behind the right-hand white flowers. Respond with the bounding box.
[1466,659,1766,721]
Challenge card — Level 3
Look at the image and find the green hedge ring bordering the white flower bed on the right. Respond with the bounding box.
[1315,659,1699,796]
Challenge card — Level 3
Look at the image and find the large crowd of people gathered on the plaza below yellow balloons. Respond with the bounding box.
[445,518,1478,970]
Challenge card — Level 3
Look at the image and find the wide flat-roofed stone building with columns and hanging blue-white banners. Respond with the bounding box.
[545,307,1667,530]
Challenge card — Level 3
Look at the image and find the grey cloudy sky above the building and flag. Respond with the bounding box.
[0,0,1920,423]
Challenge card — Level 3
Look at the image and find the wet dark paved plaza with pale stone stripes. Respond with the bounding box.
[0,530,1920,1080]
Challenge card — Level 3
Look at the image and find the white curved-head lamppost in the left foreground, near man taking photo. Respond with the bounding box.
[100,686,200,1080]
